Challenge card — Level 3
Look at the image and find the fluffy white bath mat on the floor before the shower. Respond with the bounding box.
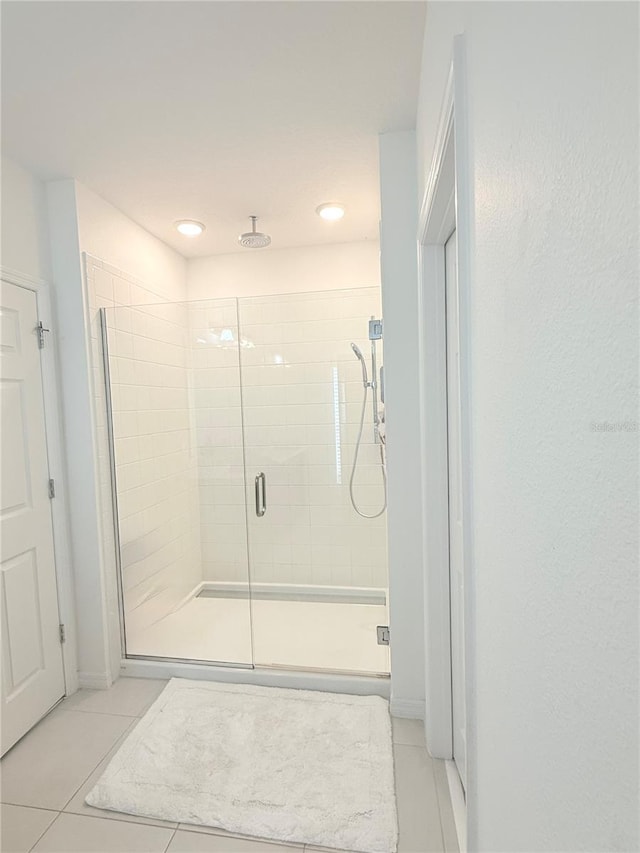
[86,678,397,853]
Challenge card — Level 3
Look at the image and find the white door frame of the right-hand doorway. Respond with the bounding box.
[418,35,477,851]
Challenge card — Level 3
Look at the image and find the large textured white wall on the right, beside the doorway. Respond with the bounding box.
[418,2,639,851]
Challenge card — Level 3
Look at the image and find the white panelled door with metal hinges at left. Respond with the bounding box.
[0,281,64,754]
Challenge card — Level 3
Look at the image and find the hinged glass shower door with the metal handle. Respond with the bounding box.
[238,288,389,674]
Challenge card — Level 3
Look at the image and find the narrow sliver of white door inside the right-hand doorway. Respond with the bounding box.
[445,231,467,788]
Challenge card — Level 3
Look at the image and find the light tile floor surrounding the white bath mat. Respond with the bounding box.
[0,678,458,853]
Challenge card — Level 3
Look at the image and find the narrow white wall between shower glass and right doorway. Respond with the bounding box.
[380,131,424,717]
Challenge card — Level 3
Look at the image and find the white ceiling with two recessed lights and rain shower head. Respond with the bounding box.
[1,0,425,257]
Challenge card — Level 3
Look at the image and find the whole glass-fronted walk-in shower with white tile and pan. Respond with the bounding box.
[102,288,389,675]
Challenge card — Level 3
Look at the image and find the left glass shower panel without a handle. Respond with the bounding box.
[103,299,252,666]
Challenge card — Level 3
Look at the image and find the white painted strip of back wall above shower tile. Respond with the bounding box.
[188,241,380,299]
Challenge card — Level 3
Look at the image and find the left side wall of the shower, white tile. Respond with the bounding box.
[85,255,202,654]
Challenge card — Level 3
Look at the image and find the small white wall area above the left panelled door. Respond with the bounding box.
[0,157,51,281]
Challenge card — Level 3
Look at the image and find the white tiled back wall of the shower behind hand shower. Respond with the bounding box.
[190,288,388,589]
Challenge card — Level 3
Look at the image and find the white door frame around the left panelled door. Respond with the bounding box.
[0,266,78,696]
